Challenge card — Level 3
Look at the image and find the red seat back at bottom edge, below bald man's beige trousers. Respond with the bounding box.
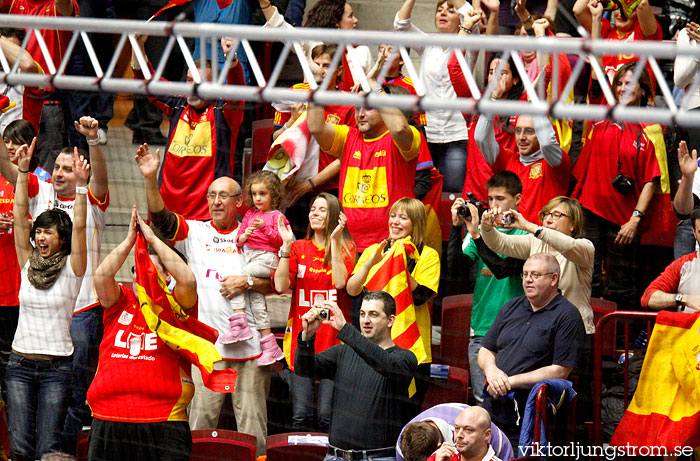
[190,429,257,461]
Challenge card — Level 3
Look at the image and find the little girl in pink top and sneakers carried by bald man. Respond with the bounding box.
[220,171,289,366]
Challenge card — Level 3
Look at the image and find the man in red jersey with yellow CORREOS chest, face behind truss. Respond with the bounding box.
[131,36,245,221]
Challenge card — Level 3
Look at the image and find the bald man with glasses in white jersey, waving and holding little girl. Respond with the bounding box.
[136,144,270,455]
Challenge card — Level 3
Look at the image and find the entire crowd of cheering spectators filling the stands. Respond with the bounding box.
[0,0,700,461]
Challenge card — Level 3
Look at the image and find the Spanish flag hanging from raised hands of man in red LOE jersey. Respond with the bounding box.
[135,233,236,392]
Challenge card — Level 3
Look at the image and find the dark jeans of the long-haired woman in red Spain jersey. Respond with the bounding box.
[282,369,333,432]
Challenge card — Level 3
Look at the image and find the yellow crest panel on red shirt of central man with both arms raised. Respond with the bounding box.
[343,166,389,208]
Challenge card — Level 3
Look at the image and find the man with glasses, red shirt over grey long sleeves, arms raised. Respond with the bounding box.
[474,114,571,222]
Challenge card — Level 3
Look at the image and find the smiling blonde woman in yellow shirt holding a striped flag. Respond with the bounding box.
[346,197,440,363]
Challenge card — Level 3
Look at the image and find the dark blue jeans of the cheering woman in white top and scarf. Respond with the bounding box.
[6,353,73,460]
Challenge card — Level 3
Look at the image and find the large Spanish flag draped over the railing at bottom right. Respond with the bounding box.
[610,311,700,453]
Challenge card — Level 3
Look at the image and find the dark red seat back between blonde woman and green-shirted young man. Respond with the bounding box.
[440,294,473,370]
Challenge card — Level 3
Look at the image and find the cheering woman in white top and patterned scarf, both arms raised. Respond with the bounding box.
[6,139,90,461]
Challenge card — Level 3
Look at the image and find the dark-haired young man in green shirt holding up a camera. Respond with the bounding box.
[447,171,527,403]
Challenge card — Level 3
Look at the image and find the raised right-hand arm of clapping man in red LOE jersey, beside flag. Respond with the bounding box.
[136,215,197,309]
